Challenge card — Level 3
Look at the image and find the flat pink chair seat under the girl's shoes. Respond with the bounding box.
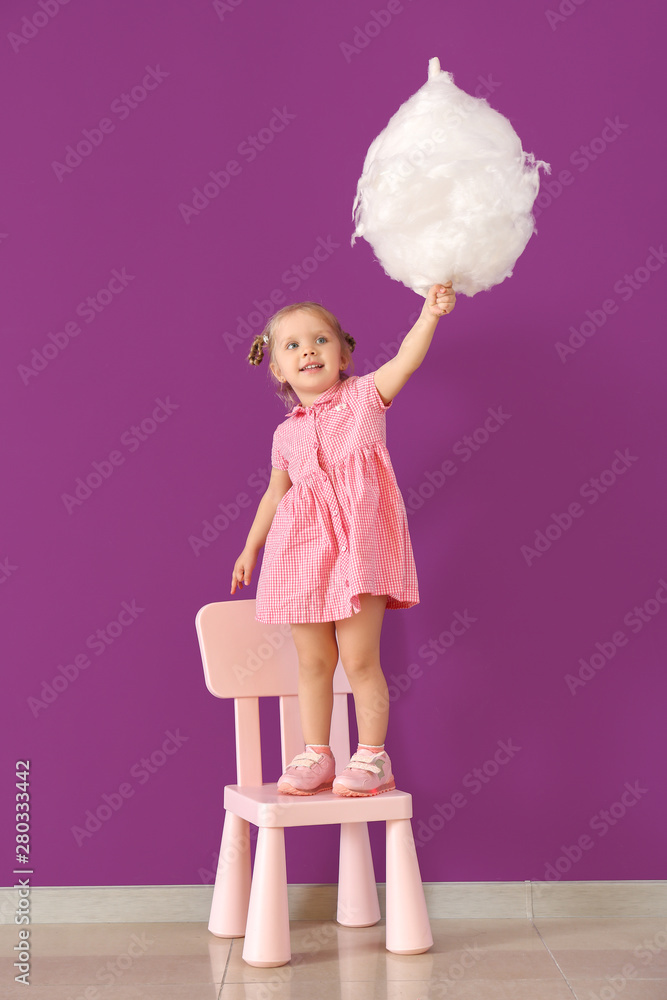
[225,781,412,827]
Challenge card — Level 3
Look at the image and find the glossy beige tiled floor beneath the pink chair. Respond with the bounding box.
[0,916,667,1000]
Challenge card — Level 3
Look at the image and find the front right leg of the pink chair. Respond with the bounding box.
[386,819,433,955]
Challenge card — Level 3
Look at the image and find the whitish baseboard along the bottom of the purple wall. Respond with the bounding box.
[0,880,667,924]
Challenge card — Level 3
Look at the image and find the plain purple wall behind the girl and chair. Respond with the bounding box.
[0,0,667,886]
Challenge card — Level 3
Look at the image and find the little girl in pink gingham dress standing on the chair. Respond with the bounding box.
[231,281,456,795]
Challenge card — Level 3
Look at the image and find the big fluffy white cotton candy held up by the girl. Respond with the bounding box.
[351,59,551,297]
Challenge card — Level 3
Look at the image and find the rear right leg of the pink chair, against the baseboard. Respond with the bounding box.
[336,823,380,927]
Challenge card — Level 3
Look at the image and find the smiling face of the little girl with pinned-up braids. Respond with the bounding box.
[271,309,348,406]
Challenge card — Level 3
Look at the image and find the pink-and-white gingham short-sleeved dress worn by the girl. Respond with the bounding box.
[255,372,419,624]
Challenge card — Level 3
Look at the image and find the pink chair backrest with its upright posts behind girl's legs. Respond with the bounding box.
[195,599,351,785]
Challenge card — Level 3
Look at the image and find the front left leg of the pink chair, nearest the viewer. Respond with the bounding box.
[243,826,292,968]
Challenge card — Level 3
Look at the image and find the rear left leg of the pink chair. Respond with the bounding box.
[208,812,251,937]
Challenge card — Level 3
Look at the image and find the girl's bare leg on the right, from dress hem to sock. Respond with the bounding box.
[336,594,389,746]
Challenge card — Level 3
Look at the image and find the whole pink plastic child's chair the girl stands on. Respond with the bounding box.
[196,600,433,967]
